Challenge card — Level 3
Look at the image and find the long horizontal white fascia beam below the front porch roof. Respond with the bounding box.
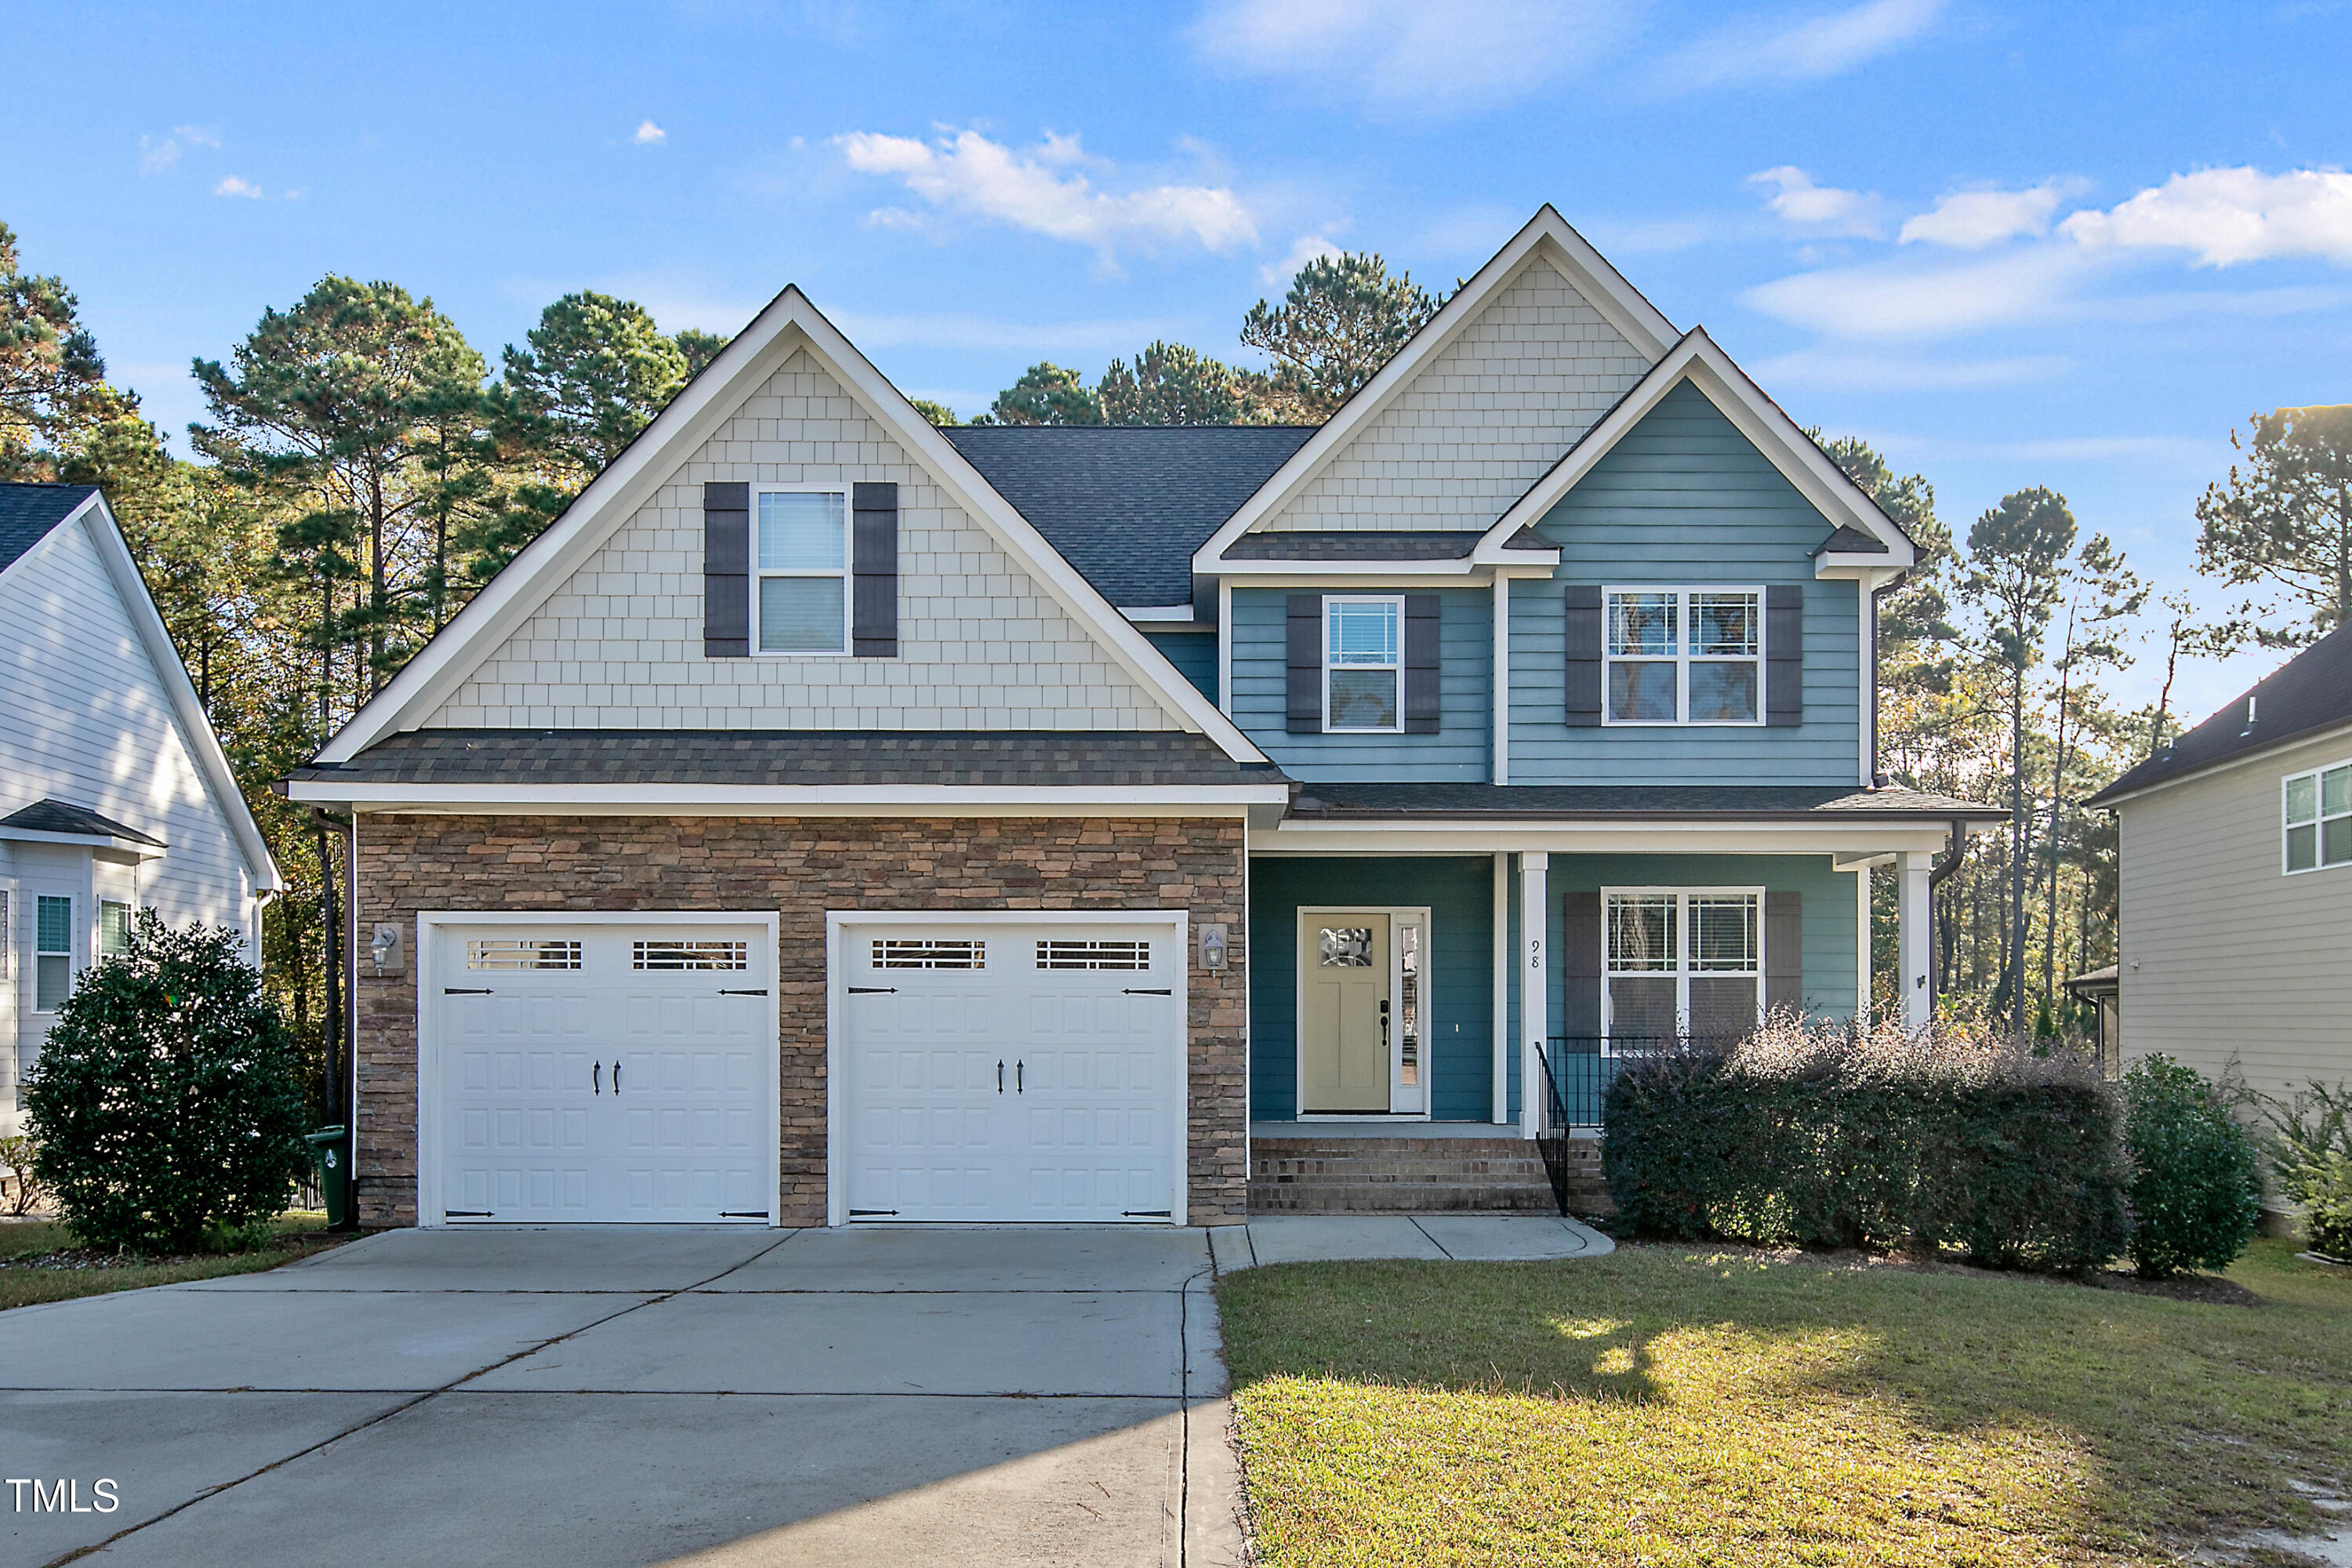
[1249,818,1976,855]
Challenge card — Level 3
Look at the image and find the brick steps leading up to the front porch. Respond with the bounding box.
[1249,1133,1606,1213]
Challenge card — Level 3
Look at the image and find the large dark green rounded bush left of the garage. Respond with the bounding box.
[24,909,308,1253]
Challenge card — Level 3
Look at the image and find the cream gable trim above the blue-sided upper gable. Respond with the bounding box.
[1486,327,1917,567]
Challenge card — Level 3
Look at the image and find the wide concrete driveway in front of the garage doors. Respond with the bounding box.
[0,1227,1242,1568]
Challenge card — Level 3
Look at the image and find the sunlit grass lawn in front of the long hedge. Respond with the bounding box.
[1216,1241,2352,1568]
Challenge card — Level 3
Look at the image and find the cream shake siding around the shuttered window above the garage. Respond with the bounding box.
[423,353,1178,729]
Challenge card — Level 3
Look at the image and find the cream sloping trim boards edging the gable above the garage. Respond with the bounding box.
[318,285,1265,762]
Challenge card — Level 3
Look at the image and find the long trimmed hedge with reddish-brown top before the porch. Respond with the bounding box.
[1602,1018,2126,1272]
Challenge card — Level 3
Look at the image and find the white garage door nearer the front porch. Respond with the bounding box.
[835,921,1185,1222]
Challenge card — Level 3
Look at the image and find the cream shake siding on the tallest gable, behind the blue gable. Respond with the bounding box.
[1261,256,1649,529]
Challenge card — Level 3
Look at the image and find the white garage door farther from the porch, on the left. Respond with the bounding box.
[426,921,776,1225]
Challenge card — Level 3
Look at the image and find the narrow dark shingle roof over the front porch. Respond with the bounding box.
[1291,781,2009,822]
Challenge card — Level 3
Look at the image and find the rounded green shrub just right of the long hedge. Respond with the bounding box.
[2124,1055,2263,1279]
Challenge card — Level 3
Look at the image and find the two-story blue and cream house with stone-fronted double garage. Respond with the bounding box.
[287,207,1999,1225]
